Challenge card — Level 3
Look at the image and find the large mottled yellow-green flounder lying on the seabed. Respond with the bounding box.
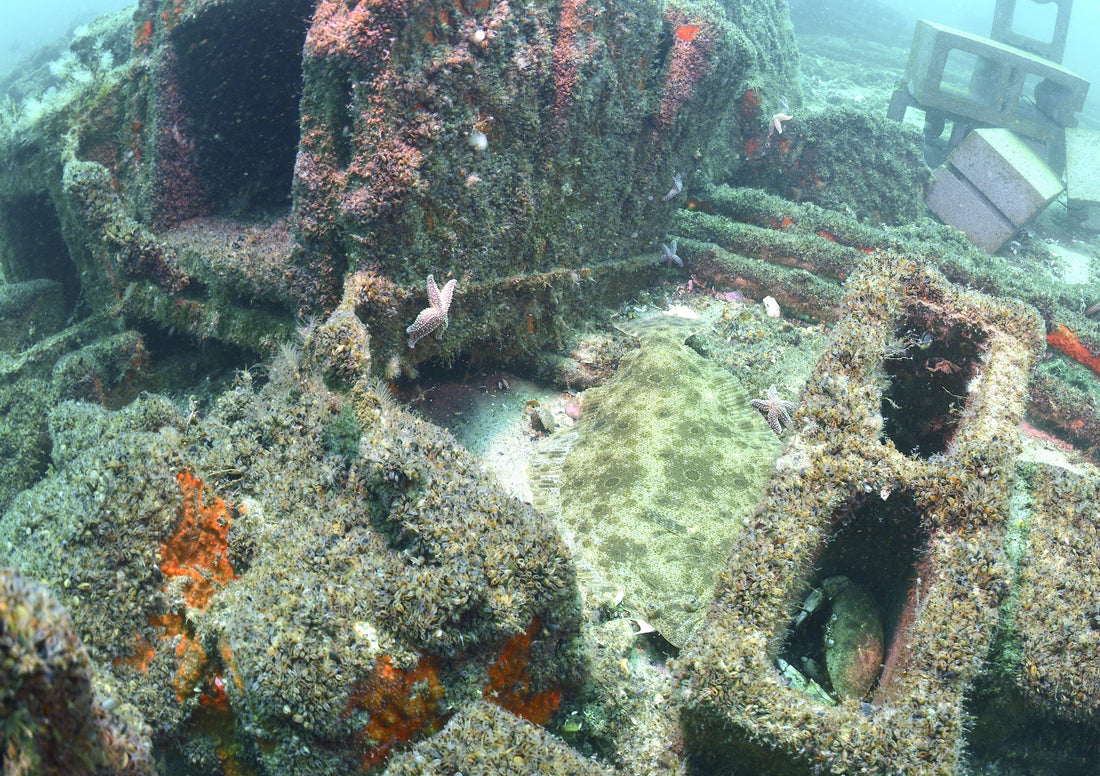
[532,305,779,646]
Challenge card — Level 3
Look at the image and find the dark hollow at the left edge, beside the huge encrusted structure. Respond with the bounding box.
[0,193,80,315]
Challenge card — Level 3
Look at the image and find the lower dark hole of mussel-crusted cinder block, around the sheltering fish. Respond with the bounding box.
[779,491,928,698]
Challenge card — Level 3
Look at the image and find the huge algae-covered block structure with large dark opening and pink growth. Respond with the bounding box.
[0,0,796,365]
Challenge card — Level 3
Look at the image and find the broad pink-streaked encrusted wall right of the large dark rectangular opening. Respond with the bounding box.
[294,0,783,361]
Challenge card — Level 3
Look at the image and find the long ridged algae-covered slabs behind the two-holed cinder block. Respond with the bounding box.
[671,185,1100,462]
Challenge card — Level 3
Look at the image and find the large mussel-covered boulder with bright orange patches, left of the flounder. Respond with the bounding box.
[0,314,584,774]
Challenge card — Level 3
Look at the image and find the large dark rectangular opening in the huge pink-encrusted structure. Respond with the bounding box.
[174,0,314,216]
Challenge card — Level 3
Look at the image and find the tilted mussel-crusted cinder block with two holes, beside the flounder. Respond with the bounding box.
[680,256,1043,776]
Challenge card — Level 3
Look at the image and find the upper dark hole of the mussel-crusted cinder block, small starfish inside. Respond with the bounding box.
[882,305,986,458]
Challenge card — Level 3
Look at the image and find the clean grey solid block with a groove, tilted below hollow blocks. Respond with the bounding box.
[926,129,1063,253]
